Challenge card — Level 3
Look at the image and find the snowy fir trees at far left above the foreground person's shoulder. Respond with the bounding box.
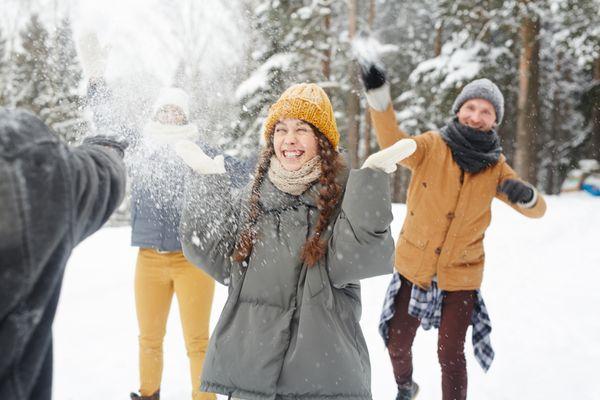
[0,14,88,143]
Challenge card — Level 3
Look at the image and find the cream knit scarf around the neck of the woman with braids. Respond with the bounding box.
[269,156,322,196]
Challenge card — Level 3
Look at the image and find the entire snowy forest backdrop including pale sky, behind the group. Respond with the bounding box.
[0,0,600,202]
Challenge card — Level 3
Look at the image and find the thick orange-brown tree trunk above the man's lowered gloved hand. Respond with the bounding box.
[515,0,540,185]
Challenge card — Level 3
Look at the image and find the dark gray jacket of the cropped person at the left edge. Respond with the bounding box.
[0,108,125,400]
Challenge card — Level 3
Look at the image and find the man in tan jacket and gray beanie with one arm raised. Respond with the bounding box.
[362,64,546,400]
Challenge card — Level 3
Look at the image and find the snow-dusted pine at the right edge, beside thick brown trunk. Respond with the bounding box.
[538,0,600,193]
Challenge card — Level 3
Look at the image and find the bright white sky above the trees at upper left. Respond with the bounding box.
[0,0,244,84]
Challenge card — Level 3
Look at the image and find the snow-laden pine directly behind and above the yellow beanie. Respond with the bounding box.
[234,0,330,156]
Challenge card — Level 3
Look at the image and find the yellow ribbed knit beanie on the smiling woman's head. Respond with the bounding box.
[263,83,340,149]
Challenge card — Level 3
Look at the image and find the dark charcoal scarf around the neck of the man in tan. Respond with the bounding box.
[441,118,502,174]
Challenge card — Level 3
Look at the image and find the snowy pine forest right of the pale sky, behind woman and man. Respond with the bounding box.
[235,0,600,197]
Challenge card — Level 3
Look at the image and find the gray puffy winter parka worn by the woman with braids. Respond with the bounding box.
[181,165,394,400]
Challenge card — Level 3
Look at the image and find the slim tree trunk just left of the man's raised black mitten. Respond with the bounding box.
[346,0,360,168]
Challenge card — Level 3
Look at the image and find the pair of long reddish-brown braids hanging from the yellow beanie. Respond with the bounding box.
[233,126,343,267]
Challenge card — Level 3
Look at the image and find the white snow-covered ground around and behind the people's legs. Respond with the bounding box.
[54,194,600,400]
